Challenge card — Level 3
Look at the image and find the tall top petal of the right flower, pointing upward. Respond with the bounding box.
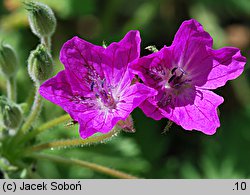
[171,19,216,86]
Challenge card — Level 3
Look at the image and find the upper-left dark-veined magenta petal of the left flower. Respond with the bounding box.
[60,37,104,91]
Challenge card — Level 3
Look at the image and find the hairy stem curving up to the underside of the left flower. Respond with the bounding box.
[28,127,120,152]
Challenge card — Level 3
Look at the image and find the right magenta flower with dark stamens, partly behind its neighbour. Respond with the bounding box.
[131,19,246,135]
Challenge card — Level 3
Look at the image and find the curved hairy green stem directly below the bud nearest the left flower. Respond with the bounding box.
[20,83,42,133]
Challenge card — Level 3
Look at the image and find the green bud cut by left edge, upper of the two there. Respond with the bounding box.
[0,43,18,77]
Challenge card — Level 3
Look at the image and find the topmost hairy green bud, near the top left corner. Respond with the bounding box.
[24,1,56,38]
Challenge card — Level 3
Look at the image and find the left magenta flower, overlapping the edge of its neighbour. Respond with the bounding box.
[40,31,157,138]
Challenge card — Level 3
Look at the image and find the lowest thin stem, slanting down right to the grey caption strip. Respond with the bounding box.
[30,154,137,179]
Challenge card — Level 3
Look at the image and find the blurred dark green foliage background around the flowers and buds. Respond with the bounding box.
[0,0,250,178]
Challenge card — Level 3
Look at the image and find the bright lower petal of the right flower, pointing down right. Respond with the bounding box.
[165,89,224,135]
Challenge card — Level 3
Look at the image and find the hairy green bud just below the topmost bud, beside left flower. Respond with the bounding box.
[28,44,53,82]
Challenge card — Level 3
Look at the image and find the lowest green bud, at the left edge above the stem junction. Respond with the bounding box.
[0,96,23,129]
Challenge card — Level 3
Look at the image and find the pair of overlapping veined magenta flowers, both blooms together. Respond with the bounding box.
[40,19,246,138]
